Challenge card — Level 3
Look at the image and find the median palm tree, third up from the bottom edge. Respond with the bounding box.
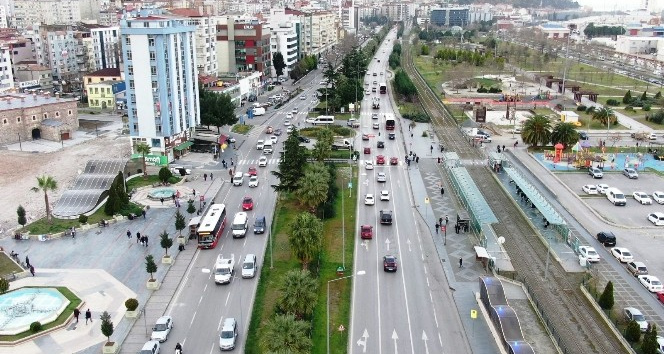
[288,212,323,269]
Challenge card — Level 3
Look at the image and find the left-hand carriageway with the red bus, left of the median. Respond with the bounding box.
[163,70,322,353]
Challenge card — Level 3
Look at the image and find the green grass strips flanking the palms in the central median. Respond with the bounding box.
[245,167,357,354]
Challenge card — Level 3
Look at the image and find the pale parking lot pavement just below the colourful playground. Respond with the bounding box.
[556,172,664,227]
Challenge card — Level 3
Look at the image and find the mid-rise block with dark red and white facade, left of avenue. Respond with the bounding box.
[217,16,272,77]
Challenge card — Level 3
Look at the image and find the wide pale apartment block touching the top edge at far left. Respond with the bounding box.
[11,0,81,28]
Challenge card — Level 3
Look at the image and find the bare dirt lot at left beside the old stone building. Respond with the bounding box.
[0,120,129,237]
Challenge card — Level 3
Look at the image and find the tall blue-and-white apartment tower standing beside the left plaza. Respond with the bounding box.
[120,9,200,161]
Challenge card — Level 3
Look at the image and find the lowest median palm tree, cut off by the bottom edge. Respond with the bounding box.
[261,314,313,354]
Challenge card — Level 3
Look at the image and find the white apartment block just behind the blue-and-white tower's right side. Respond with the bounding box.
[171,9,219,76]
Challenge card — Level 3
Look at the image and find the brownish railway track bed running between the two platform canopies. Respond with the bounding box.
[402,34,625,354]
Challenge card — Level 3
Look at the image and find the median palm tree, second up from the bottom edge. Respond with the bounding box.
[277,269,318,319]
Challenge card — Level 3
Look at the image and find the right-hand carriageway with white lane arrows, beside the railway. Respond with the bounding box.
[348,30,471,353]
